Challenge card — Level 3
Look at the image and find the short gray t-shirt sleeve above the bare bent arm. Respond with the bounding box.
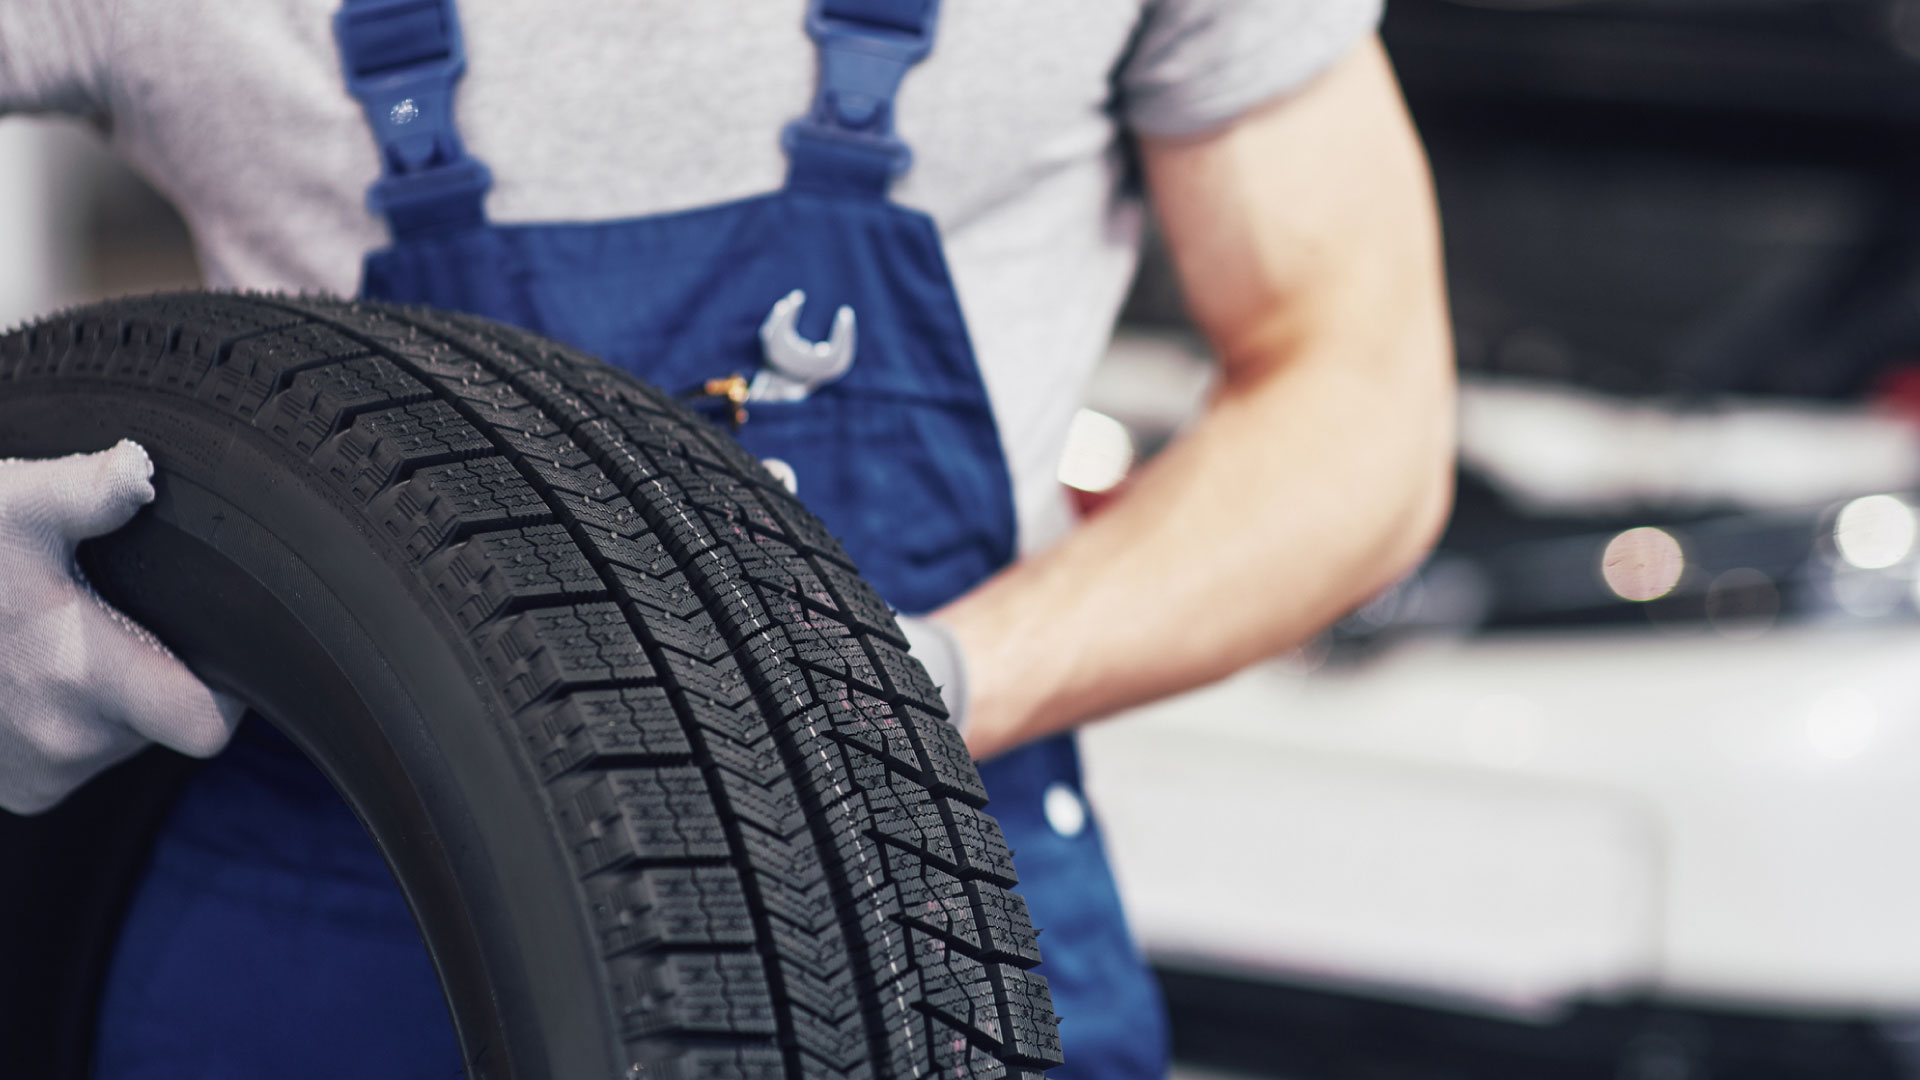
[1117,0,1382,135]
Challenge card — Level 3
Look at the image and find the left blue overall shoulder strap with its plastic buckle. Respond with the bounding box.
[334,0,493,240]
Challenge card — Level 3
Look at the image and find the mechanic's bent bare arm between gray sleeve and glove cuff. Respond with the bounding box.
[939,42,1453,757]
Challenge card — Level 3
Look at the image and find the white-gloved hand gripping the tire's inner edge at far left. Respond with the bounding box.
[0,440,244,813]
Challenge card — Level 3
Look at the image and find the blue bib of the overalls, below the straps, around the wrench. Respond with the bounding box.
[367,188,1014,611]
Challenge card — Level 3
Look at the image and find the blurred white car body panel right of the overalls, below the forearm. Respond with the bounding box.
[1083,625,1920,1011]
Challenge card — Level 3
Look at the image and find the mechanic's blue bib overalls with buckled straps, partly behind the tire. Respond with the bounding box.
[96,0,1165,1080]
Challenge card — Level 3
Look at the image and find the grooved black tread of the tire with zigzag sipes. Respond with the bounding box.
[0,294,1060,1080]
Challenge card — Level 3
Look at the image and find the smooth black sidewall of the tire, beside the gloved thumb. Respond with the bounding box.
[0,377,626,1078]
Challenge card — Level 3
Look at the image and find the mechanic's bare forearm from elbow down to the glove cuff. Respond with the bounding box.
[943,303,1452,757]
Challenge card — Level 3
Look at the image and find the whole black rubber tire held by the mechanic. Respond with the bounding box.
[0,294,1060,1080]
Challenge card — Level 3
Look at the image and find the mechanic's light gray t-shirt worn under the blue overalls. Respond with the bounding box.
[0,0,1380,552]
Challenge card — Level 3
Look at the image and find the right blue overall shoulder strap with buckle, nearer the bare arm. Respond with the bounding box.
[783,0,939,198]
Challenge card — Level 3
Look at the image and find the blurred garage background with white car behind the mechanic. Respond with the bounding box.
[11,0,1920,1080]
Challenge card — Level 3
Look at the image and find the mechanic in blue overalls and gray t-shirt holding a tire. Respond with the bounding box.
[0,0,1452,1080]
